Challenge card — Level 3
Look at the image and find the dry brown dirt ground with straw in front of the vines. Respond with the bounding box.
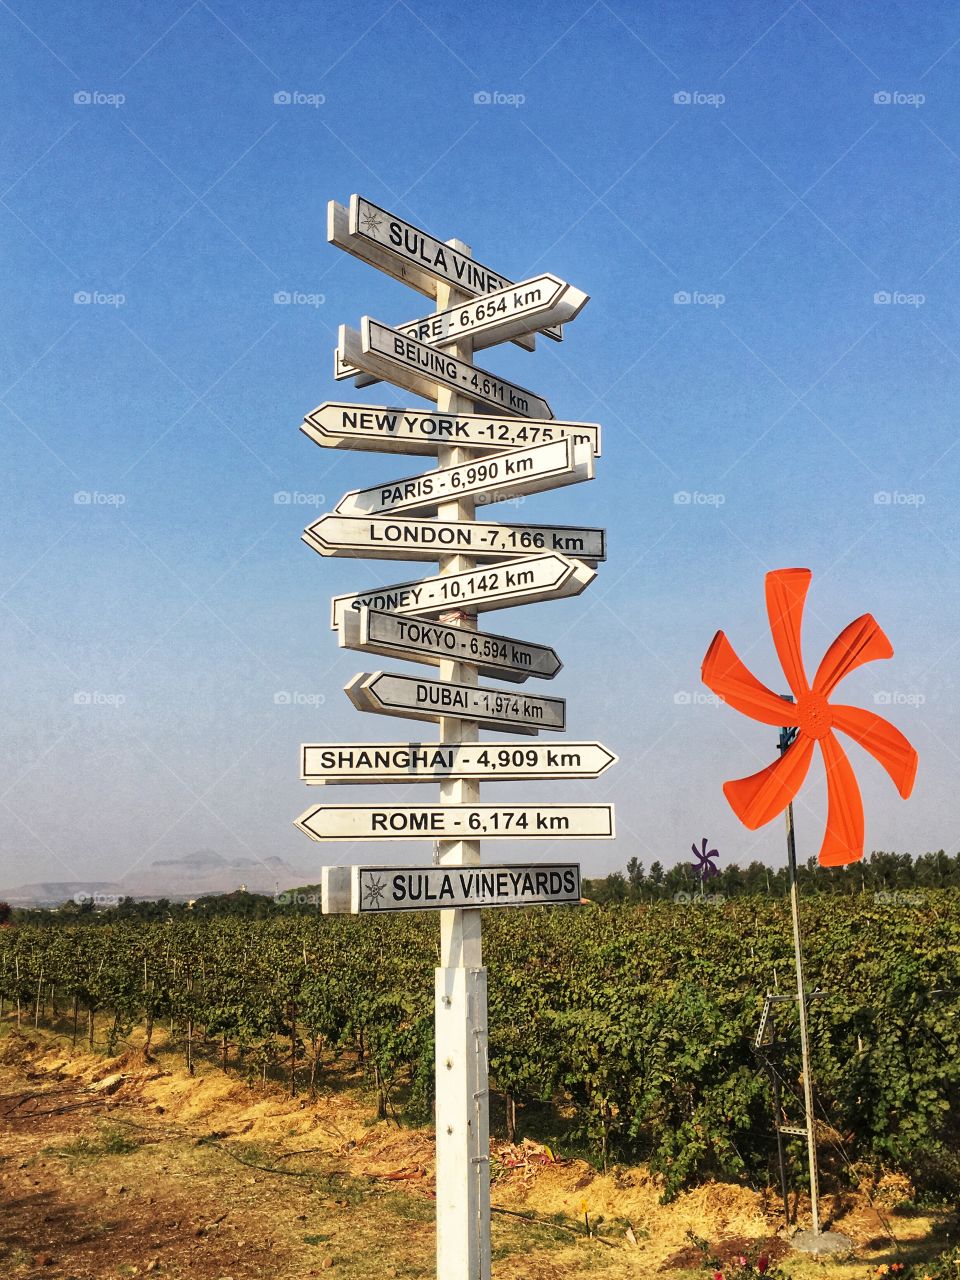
[0,1028,941,1280]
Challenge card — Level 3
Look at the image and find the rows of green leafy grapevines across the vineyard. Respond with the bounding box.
[0,890,960,1196]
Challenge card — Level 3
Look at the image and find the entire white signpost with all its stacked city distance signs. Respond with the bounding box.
[297,196,617,1280]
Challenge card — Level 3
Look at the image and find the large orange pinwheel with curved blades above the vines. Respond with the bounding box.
[701,568,916,867]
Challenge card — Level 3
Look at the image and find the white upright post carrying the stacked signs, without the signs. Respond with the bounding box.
[434,241,490,1280]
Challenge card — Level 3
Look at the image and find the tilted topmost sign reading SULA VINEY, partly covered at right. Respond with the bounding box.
[326,196,563,346]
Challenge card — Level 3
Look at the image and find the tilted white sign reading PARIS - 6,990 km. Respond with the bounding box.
[334,439,594,516]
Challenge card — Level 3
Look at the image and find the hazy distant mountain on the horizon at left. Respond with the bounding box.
[0,849,307,906]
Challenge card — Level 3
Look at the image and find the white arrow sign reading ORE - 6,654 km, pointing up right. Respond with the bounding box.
[334,273,590,387]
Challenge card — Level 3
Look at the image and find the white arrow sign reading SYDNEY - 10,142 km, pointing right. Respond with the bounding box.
[330,552,596,631]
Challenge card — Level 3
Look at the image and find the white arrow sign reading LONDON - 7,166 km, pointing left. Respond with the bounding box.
[302,515,607,564]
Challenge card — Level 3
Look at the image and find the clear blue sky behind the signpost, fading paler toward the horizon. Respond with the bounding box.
[0,0,960,887]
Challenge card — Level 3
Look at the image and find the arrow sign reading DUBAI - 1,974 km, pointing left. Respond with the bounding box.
[344,671,567,733]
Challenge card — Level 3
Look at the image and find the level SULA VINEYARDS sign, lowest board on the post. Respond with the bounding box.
[320,863,580,915]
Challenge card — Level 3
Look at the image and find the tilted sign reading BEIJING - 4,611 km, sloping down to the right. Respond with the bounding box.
[338,316,553,419]
